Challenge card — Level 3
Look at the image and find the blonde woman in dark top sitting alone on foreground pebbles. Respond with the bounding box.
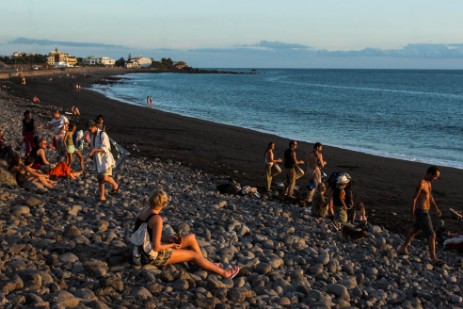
[134,189,240,278]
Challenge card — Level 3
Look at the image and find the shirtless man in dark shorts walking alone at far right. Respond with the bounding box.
[399,166,445,266]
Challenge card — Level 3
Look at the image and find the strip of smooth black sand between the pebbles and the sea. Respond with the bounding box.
[3,70,463,232]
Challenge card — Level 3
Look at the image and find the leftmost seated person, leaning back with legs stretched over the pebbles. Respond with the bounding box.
[9,153,56,189]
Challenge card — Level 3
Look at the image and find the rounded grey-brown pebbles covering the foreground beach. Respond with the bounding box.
[0,71,463,308]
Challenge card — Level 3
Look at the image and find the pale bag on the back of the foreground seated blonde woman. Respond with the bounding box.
[130,214,158,264]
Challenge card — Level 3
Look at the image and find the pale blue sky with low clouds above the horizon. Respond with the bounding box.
[0,0,463,69]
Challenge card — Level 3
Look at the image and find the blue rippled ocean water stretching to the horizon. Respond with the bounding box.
[92,69,463,169]
